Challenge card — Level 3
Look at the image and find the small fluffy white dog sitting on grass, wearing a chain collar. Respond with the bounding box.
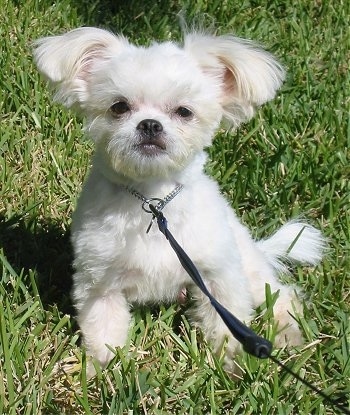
[35,27,324,366]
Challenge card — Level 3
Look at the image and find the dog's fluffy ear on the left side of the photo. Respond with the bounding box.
[34,27,129,107]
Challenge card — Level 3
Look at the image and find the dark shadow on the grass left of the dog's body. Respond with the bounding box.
[0,216,74,314]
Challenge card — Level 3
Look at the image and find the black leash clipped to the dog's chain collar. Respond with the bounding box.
[148,203,350,415]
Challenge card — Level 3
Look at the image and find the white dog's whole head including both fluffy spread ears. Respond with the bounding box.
[35,27,284,180]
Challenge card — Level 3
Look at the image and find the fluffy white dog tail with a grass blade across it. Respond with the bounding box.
[257,221,327,273]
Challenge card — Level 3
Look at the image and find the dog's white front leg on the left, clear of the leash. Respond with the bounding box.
[77,290,130,367]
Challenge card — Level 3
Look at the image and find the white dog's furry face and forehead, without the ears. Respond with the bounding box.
[84,43,222,180]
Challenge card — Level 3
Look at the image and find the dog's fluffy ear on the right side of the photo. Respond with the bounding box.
[184,33,284,126]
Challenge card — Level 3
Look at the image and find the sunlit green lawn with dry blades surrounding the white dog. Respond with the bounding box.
[0,0,350,415]
